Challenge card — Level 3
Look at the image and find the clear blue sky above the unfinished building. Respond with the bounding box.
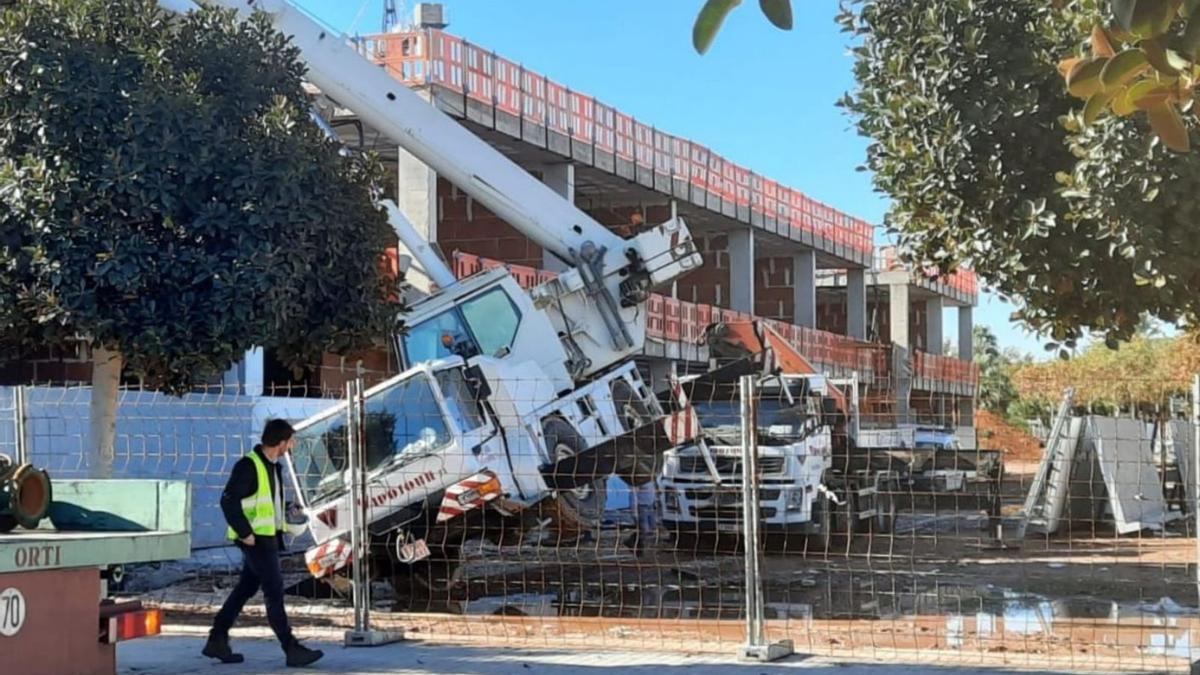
[299,0,1044,354]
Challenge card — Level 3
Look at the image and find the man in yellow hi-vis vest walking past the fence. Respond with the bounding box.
[202,419,324,667]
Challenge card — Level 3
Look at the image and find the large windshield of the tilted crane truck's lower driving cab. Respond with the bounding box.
[292,372,451,503]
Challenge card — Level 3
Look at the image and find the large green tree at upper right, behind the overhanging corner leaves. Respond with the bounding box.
[840,0,1200,347]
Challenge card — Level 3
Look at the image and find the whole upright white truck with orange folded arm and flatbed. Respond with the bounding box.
[659,322,1002,552]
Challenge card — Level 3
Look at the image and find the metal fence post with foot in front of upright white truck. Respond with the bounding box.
[740,375,793,662]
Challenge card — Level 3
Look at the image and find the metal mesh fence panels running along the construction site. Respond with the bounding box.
[0,366,1200,671]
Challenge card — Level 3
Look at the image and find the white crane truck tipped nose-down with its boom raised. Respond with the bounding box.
[161,0,701,590]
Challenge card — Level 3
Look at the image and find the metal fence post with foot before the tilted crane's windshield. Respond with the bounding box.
[346,377,404,647]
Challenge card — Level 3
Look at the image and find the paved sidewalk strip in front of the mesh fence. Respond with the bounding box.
[116,637,1089,675]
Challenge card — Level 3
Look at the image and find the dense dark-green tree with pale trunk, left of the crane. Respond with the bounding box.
[0,0,391,474]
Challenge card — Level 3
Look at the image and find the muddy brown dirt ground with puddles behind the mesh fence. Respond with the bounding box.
[138,458,1200,673]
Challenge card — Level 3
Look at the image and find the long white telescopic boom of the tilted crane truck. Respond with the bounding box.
[160,0,702,367]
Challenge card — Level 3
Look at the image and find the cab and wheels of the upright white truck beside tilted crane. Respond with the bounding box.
[659,365,904,552]
